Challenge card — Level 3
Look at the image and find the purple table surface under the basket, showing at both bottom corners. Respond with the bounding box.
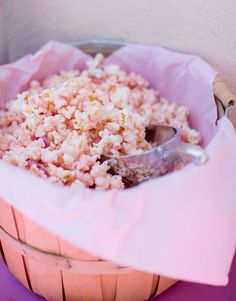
[0,252,236,301]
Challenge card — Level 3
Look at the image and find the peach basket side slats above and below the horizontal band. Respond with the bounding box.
[0,199,175,301]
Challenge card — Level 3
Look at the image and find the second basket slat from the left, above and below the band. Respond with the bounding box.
[24,216,63,301]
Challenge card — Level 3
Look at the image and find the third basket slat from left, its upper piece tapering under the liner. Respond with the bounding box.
[59,240,103,301]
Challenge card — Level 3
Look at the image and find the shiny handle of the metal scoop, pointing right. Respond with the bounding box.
[163,143,208,165]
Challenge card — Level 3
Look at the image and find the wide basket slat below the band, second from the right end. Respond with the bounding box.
[115,271,153,301]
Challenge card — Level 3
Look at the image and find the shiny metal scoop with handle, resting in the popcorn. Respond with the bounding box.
[105,125,207,187]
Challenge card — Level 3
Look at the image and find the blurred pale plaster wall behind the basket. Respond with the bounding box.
[0,0,236,91]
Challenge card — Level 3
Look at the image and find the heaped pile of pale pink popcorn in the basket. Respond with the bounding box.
[0,54,200,189]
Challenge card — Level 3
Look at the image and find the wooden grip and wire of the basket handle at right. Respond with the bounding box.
[213,75,236,129]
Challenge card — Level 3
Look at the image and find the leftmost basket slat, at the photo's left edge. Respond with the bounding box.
[0,199,30,288]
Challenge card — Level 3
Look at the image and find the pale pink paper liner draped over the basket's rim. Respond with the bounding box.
[0,42,236,285]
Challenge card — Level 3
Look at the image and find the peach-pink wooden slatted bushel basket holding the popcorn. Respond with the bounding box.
[0,41,234,301]
